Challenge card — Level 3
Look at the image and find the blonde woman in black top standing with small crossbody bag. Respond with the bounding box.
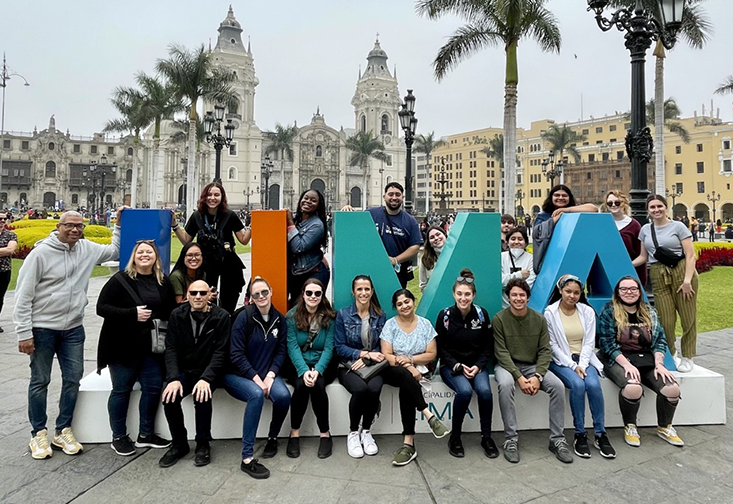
[97,240,175,456]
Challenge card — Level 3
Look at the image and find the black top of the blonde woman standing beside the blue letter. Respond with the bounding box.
[97,271,176,372]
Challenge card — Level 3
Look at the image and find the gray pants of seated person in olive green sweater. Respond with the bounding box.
[494,362,565,442]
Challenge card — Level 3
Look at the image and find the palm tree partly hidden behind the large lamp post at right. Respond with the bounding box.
[611,0,713,194]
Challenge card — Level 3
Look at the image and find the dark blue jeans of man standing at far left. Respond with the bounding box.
[28,326,86,436]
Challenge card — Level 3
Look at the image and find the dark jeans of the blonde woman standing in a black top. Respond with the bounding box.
[107,355,163,439]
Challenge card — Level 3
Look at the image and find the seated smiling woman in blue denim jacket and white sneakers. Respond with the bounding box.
[334,275,386,458]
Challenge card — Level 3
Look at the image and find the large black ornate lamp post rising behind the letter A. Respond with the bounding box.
[588,0,685,225]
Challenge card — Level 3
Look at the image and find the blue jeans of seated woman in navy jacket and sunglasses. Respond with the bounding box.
[224,374,290,460]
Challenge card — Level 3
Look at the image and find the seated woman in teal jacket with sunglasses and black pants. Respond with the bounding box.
[286,278,336,458]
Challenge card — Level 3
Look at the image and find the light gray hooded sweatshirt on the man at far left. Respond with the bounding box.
[13,226,120,341]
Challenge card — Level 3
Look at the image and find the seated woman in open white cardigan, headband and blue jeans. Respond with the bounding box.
[545,275,616,458]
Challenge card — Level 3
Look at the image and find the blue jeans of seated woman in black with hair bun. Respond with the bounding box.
[440,366,494,436]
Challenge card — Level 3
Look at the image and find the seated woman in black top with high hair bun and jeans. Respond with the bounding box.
[435,269,499,458]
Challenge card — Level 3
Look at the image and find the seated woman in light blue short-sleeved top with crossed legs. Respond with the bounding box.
[381,289,450,466]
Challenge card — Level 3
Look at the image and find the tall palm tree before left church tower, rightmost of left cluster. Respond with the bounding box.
[157,44,237,215]
